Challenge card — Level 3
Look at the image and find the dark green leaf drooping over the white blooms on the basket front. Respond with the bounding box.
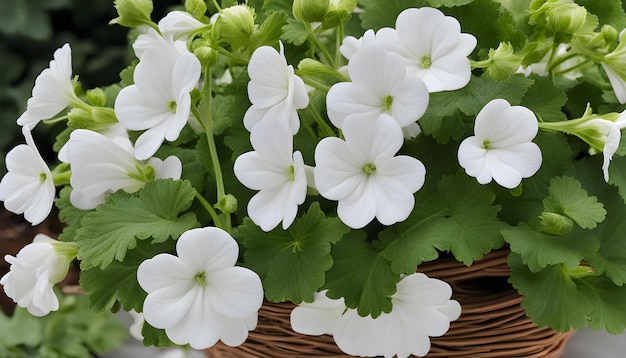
[325,230,394,318]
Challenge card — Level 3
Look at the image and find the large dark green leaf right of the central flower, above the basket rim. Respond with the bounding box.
[379,171,508,274]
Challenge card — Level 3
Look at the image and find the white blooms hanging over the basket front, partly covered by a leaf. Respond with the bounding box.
[291,273,461,358]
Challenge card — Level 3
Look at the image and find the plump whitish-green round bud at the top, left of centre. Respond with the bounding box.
[214,5,256,49]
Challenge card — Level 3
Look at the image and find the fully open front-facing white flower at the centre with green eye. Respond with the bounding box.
[314,114,426,229]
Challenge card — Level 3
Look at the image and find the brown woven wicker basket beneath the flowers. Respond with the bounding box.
[207,248,573,358]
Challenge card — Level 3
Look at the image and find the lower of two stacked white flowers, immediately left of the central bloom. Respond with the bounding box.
[234,119,307,231]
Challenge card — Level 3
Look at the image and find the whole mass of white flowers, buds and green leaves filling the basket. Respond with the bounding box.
[0,0,626,357]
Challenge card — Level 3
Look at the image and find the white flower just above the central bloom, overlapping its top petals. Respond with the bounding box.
[326,45,429,128]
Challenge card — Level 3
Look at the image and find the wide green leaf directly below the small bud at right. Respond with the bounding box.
[502,224,600,272]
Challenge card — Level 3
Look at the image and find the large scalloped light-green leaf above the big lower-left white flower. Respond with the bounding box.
[76,179,196,269]
